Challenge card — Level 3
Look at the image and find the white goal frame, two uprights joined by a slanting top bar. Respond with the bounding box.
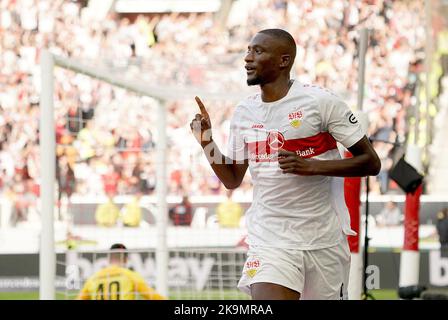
[39,51,172,300]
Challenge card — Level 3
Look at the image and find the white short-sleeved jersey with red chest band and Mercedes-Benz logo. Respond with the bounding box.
[228,81,364,250]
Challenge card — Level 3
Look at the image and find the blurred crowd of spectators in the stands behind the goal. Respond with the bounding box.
[0,0,434,225]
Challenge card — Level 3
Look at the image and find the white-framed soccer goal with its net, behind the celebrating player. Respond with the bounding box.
[40,52,250,299]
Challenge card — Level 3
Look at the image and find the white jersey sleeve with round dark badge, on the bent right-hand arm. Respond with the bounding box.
[319,95,364,148]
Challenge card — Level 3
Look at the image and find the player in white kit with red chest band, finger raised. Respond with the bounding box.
[190,29,381,300]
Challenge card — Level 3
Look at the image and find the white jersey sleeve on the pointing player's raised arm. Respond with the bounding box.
[227,107,248,161]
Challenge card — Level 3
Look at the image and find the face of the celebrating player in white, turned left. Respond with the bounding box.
[244,33,280,86]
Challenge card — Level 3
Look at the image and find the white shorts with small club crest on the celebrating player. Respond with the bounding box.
[238,237,350,300]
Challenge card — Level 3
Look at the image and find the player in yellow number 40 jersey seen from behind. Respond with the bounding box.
[77,243,166,300]
